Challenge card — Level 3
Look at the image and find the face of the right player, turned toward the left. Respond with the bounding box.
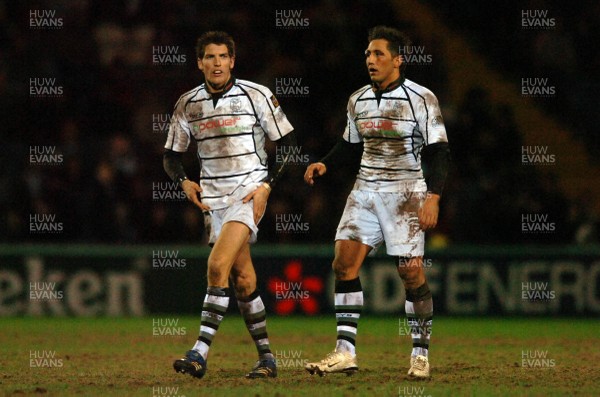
[365,39,402,88]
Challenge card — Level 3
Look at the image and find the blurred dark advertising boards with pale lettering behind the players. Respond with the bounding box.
[0,241,600,316]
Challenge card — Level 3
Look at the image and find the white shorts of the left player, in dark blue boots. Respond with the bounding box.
[204,200,260,247]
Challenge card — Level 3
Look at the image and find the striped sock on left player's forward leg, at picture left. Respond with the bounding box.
[192,287,229,360]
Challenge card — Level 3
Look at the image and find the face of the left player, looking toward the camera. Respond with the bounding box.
[198,44,235,92]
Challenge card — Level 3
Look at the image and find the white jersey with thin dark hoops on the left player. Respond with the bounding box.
[165,79,293,209]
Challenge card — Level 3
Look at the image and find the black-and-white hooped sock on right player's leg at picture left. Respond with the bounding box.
[335,277,363,356]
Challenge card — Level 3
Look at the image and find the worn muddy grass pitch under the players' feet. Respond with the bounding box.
[0,315,600,397]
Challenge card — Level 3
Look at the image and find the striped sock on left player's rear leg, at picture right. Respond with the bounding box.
[238,290,273,360]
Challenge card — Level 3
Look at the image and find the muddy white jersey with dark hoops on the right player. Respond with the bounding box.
[344,79,448,192]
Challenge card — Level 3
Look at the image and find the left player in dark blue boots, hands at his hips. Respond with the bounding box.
[163,31,295,378]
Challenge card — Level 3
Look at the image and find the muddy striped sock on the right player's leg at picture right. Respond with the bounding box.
[404,281,433,357]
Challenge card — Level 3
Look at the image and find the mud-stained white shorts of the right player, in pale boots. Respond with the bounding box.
[335,181,427,257]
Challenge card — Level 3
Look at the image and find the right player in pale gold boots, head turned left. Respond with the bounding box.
[304,26,449,378]
